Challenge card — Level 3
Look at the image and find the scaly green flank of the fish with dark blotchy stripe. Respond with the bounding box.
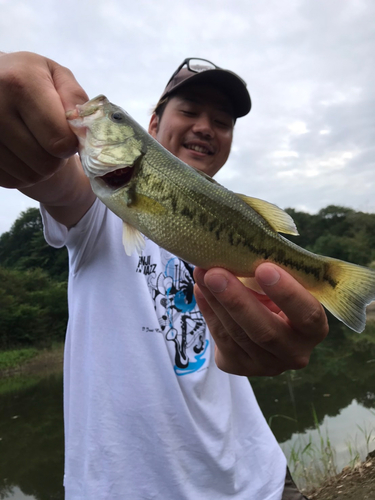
[131,146,326,288]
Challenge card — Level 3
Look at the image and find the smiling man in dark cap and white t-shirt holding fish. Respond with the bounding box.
[0,53,327,500]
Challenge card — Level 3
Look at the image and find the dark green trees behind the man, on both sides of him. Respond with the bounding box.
[0,205,375,349]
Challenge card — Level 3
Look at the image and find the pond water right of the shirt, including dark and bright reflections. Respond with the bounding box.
[251,318,375,476]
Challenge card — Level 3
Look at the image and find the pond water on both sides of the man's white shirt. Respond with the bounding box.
[0,320,375,500]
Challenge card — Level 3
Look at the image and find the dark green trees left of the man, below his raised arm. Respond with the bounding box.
[0,208,68,350]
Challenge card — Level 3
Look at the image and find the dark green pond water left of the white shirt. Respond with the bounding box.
[0,375,64,500]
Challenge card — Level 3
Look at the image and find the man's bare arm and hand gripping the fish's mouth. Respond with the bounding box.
[0,52,95,227]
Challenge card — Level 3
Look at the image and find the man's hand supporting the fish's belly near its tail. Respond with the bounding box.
[194,263,328,377]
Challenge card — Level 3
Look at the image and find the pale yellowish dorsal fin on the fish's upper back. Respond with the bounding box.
[236,193,299,236]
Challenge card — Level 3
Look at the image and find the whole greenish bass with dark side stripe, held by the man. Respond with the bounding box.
[66,95,375,332]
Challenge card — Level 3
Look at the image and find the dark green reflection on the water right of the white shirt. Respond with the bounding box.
[251,319,375,442]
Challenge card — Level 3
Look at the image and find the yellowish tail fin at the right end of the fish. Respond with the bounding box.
[310,257,375,333]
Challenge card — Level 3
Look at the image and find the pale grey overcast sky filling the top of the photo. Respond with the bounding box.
[0,0,375,234]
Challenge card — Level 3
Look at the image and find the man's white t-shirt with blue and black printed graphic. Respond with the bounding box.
[42,200,286,500]
